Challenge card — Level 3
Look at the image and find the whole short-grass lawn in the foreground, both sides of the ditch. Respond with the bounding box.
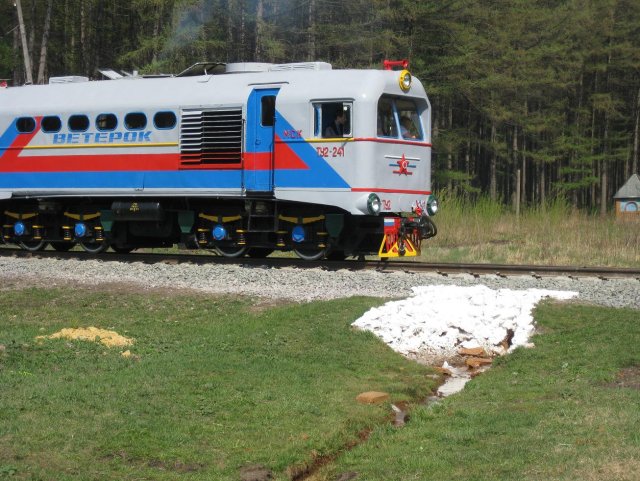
[0,289,640,481]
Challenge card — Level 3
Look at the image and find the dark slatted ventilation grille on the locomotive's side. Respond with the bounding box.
[180,109,242,165]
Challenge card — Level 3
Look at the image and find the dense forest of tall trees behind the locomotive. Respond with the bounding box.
[0,0,640,214]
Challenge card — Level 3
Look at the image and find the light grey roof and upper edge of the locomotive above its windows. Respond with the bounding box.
[0,64,426,115]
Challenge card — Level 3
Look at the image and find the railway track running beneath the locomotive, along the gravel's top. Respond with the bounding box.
[0,246,640,281]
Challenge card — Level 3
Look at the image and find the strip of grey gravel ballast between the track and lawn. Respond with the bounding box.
[0,257,640,309]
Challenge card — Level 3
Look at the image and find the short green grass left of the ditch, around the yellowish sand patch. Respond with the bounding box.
[0,289,435,481]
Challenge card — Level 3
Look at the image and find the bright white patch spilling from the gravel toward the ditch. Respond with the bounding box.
[353,285,578,357]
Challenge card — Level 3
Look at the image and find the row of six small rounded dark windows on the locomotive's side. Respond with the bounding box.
[16,112,177,134]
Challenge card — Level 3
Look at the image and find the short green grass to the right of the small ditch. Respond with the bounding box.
[313,305,640,481]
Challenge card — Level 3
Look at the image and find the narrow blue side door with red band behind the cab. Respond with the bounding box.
[243,89,279,192]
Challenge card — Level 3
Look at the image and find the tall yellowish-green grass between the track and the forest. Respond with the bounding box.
[421,197,640,267]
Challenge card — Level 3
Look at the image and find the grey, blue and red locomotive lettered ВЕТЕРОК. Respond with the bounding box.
[0,62,437,260]
